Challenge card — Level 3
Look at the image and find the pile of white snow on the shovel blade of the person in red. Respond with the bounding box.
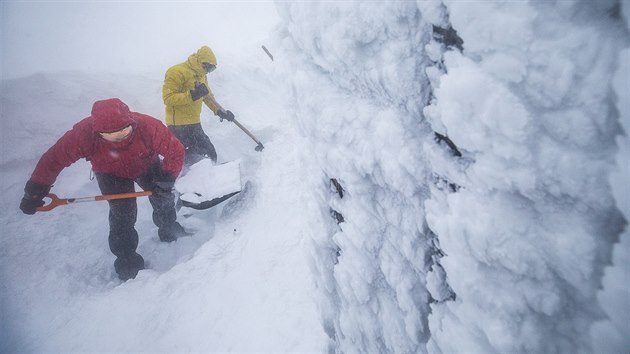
[175,159,243,209]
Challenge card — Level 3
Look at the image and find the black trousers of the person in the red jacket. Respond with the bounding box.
[96,160,177,257]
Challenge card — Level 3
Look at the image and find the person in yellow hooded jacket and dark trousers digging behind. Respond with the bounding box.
[162,46,234,166]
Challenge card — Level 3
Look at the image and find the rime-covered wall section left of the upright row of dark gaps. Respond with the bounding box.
[275,1,442,353]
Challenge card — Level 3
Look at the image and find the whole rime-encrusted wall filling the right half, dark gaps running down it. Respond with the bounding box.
[276,1,630,353]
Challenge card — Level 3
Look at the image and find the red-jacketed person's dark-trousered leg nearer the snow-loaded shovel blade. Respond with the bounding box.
[136,160,184,242]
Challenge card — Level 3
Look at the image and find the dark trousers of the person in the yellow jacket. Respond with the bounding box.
[168,123,217,166]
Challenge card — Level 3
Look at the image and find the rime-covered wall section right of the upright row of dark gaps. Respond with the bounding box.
[425,1,628,352]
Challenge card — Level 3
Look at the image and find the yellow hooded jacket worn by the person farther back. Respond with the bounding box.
[162,46,219,125]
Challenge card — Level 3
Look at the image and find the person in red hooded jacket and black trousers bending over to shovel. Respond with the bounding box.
[20,98,185,280]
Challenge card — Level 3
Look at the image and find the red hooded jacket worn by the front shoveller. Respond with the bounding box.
[31,98,184,185]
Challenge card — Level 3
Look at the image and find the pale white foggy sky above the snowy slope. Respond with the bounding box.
[0,1,278,79]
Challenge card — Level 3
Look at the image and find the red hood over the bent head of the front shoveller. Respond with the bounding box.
[92,98,134,133]
